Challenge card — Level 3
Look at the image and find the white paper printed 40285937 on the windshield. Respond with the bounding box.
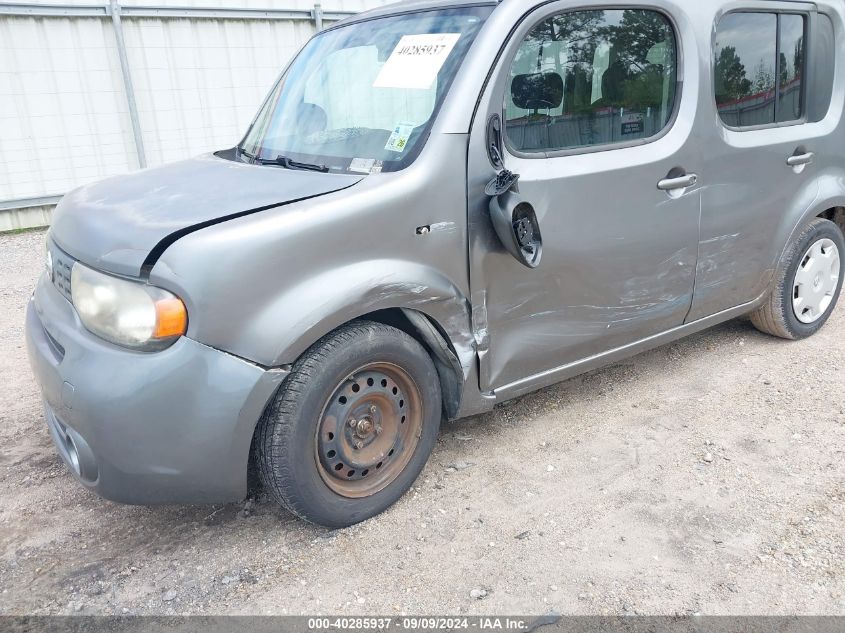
[373,33,461,90]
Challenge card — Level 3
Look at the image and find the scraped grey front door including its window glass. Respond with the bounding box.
[469,3,701,392]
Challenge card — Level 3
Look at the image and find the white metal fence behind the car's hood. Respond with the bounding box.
[0,0,387,231]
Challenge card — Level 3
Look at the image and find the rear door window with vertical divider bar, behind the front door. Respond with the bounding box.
[713,13,807,128]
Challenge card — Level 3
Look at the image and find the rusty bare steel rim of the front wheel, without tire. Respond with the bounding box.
[315,363,423,498]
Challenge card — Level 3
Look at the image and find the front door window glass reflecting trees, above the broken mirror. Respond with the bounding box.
[505,9,677,153]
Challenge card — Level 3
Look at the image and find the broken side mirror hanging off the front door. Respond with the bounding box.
[484,115,543,268]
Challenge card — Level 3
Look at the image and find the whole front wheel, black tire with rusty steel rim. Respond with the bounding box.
[256,321,441,528]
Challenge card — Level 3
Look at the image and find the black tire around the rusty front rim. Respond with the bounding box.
[256,321,442,528]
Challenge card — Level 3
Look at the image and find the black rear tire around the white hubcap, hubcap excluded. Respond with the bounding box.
[750,218,845,340]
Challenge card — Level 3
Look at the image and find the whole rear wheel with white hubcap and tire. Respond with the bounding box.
[751,218,845,340]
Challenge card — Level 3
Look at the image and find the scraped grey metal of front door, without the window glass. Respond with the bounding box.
[469,2,701,392]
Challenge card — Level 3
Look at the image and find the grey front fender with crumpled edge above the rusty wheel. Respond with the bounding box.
[149,135,474,402]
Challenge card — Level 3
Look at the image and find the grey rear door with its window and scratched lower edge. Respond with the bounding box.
[688,2,826,321]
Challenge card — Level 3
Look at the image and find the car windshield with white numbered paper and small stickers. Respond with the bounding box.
[239,7,492,174]
